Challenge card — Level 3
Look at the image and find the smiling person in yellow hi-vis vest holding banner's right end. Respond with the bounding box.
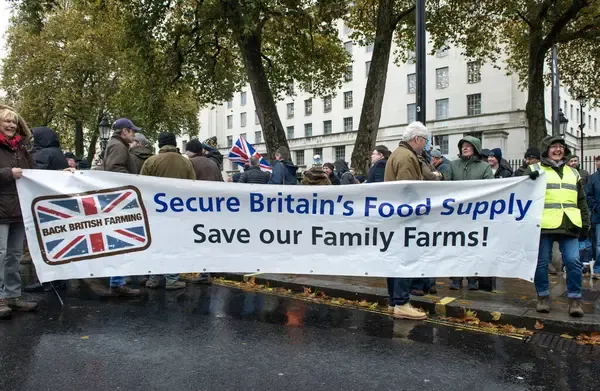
[524,136,590,317]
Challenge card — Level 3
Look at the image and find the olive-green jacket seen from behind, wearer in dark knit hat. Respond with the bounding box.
[140,145,196,179]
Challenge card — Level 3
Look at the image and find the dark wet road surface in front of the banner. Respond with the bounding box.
[0,285,600,391]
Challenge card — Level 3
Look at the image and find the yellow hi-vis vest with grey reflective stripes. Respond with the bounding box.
[531,163,582,229]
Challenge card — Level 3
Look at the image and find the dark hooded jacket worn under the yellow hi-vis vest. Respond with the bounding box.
[523,136,590,237]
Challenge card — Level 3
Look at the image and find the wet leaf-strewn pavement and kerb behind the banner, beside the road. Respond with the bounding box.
[218,273,600,333]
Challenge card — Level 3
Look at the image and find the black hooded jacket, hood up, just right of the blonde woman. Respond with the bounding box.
[32,126,69,170]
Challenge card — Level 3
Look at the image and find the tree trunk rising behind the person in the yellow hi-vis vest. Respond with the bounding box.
[525,29,548,146]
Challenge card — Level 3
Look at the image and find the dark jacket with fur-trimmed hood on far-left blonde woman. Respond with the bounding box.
[0,105,35,224]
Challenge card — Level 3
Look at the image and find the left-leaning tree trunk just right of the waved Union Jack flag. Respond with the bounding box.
[238,32,289,161]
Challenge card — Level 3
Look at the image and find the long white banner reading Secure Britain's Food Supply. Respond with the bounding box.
[17,170,546,281]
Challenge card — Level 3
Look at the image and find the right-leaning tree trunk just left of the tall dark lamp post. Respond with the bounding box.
[351,0,398,175]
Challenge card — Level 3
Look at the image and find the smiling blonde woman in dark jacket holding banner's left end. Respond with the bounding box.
[0,105,37,319]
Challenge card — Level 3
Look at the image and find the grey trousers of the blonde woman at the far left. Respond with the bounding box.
[0,223,25,299]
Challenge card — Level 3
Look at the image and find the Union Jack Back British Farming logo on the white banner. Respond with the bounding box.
[32,186,151,264]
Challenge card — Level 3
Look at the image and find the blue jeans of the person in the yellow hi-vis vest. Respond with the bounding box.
[534,234,583,299]
